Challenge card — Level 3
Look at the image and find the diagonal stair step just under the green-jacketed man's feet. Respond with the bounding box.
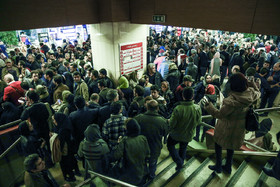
[163,159,201,187]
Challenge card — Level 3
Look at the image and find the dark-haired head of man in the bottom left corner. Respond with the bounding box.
[24,154,45,173]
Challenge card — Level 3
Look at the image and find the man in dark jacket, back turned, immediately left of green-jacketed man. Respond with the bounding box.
[134,100,168,179]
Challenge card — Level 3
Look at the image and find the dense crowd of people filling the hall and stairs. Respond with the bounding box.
[0,27,280,186]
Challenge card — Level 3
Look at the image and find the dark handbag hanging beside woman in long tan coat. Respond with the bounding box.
[245,105,260,131]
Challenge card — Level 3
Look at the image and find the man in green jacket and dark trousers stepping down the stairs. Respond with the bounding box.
[167,87,201,171]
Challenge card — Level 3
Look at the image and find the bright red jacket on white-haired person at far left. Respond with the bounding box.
[3,81,24,106]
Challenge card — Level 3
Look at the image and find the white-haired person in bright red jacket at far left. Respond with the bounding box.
[3,74,24,106]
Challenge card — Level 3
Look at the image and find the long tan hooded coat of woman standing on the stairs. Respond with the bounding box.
[205,84,260,150]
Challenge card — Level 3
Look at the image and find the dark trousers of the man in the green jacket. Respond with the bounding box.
[167,136,188,167]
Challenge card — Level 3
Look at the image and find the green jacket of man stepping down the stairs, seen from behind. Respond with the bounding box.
[169,101,202,143]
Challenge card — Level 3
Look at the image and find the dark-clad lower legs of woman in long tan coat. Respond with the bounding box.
[215,143,234,170]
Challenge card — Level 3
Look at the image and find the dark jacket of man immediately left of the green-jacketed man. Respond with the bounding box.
[134,111,168,158]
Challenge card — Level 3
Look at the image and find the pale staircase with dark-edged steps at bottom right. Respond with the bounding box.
[142,147,280,187]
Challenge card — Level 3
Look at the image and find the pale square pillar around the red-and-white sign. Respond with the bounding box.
[90,22,149,80]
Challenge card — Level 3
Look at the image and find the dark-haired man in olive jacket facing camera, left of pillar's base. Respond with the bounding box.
[73,71,89,102]
